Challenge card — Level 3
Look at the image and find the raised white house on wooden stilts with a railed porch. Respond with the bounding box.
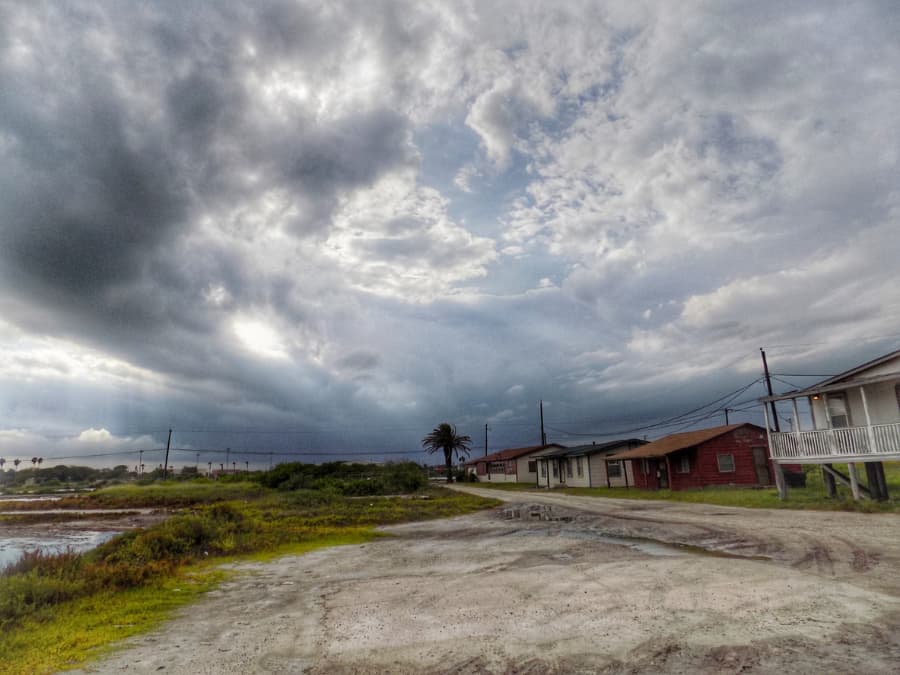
[759,350,900,499]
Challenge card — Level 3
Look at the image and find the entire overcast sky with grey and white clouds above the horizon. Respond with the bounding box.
[0,0,900,465]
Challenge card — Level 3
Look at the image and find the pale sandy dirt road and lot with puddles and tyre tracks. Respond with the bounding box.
[65,488,900,675]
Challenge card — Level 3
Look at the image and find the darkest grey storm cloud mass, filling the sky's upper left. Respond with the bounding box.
[0,3,412,344]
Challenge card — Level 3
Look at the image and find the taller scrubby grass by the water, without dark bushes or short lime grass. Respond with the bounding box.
[0,482,497,673]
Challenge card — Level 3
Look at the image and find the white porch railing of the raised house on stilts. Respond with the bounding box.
[772,423,900,462]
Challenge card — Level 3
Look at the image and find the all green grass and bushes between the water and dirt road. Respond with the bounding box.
[0,464,496,673]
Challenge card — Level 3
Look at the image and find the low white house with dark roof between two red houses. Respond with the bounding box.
[535,438,647,488]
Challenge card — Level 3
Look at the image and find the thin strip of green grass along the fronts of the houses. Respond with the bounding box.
[478,462,900,513]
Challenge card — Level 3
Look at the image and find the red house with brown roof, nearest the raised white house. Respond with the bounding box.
[610,423,788,490]
